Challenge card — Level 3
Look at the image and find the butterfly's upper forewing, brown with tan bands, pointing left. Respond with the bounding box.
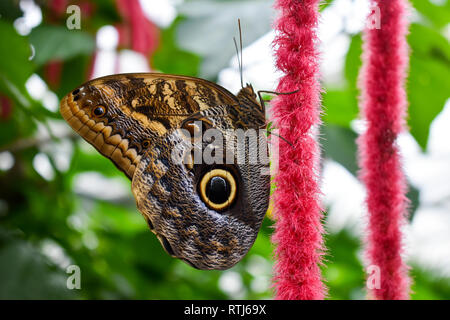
[60,73,239,179]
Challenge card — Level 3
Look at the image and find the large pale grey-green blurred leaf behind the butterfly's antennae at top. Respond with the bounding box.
[177,0,274,80]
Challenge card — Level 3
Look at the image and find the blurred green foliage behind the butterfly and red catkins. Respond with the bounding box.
[0,0,450,299]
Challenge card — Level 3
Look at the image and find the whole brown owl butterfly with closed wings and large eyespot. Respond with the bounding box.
[61,73,270,269]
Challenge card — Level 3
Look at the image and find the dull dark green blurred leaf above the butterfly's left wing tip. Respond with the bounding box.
[30,25,95,65]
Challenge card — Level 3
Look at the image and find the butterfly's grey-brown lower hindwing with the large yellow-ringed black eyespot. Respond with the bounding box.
[132,106,270,270]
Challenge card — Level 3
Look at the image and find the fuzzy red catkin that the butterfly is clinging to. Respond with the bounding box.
[272,0,326,300]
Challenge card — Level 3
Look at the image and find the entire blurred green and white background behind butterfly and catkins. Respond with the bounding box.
[0,0,450,299]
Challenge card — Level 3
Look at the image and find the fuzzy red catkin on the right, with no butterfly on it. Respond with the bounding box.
[358,0,410,300]
